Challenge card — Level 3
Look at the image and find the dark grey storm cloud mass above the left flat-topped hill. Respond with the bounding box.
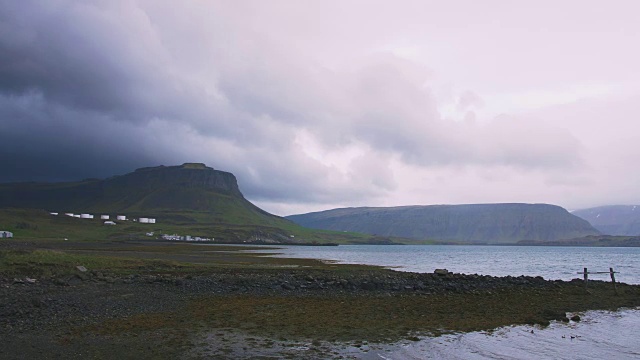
[0,2,366,200]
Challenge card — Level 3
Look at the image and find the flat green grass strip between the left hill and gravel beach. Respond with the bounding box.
[0,239,376,278]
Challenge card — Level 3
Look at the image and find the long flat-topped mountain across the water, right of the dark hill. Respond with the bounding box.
[287,204,599,243]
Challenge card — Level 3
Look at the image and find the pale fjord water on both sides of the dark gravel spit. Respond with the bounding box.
[255,245,640,360]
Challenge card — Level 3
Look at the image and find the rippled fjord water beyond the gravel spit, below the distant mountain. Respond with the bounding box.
[255,245,640,284]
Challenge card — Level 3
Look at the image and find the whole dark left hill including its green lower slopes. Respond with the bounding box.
[0,164,371,243]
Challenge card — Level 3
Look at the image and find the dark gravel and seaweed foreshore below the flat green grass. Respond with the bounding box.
[5,269,640,359]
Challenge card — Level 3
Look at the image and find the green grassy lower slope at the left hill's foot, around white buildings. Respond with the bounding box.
[0,208,402,244]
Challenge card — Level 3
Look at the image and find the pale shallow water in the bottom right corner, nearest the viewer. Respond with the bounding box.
[378,310,640,360]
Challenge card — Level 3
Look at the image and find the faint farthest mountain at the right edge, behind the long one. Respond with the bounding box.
[573,205,640,236]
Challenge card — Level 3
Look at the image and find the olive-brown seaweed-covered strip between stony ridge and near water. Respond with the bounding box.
[82,284,638,344]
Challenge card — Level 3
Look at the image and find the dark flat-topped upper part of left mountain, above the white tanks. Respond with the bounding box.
[0,163,302,235]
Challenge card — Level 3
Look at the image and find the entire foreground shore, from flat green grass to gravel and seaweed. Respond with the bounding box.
[0,240,640,359]
